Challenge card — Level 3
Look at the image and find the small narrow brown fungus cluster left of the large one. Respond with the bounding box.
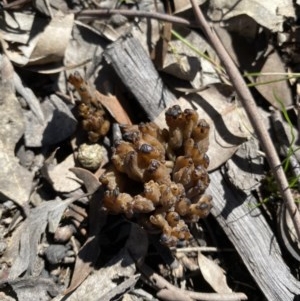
[68,72,110,142]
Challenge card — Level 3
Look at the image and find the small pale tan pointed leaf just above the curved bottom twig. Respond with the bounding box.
[198,252,232,294]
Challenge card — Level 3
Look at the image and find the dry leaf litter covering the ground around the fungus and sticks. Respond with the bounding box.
[0,1,295,300]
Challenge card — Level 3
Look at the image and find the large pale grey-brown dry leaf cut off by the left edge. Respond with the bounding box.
[0,56,33,206]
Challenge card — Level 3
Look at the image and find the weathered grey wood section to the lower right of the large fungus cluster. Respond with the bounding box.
[207,170,300,301]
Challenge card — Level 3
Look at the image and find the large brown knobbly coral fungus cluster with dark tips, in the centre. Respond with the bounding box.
[101,105,211,246]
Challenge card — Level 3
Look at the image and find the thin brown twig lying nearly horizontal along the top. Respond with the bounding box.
[77,8,199,27]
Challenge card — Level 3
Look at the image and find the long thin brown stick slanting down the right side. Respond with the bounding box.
[191,0,300,240]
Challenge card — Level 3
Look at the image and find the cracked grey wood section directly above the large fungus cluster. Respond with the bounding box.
[104,36,175,120]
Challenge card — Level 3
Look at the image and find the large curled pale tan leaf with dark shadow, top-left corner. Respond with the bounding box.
[1,12,74,66]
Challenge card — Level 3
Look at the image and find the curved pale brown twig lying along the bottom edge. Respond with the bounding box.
[138,264,247,301]
